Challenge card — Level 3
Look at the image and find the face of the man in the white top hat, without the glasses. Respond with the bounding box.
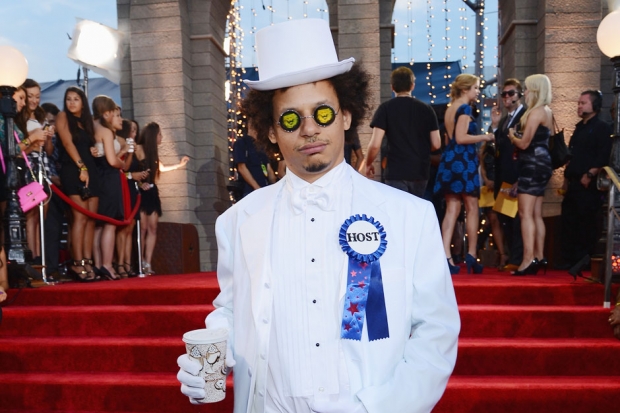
[269,80,351,182]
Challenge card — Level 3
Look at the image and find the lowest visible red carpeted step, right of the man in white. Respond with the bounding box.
[433,376,620,413]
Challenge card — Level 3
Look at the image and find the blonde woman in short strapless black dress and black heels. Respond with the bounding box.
[508,75,553,275]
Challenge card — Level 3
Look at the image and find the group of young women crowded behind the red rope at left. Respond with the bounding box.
[0,79,189,288]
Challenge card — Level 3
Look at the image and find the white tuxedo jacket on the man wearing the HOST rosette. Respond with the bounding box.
[206,167,460,413]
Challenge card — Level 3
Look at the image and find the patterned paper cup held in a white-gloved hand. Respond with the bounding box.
[183,328,228,403]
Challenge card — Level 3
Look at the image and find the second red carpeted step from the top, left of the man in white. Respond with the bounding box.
[0,305,213,337]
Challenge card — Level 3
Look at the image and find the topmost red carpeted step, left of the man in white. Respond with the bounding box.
[8,272,219,306]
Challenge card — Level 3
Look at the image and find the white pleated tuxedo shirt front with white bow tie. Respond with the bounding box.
[255,161,366,413]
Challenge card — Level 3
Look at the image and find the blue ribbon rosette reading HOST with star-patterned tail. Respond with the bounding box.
[338,214,390,341]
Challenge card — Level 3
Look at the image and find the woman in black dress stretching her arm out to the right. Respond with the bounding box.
[136,122,189,274]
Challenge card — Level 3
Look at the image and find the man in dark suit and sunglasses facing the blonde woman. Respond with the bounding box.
[491,79,525,271]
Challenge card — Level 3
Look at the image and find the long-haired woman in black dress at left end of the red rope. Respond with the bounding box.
[56,86,99,281]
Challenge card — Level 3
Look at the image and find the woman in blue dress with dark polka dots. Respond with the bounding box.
[434,74,494,274]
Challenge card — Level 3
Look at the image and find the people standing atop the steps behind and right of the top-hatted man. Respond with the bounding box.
[234,62,611,275]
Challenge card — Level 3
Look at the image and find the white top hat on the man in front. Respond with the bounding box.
[244,19,355,90]
